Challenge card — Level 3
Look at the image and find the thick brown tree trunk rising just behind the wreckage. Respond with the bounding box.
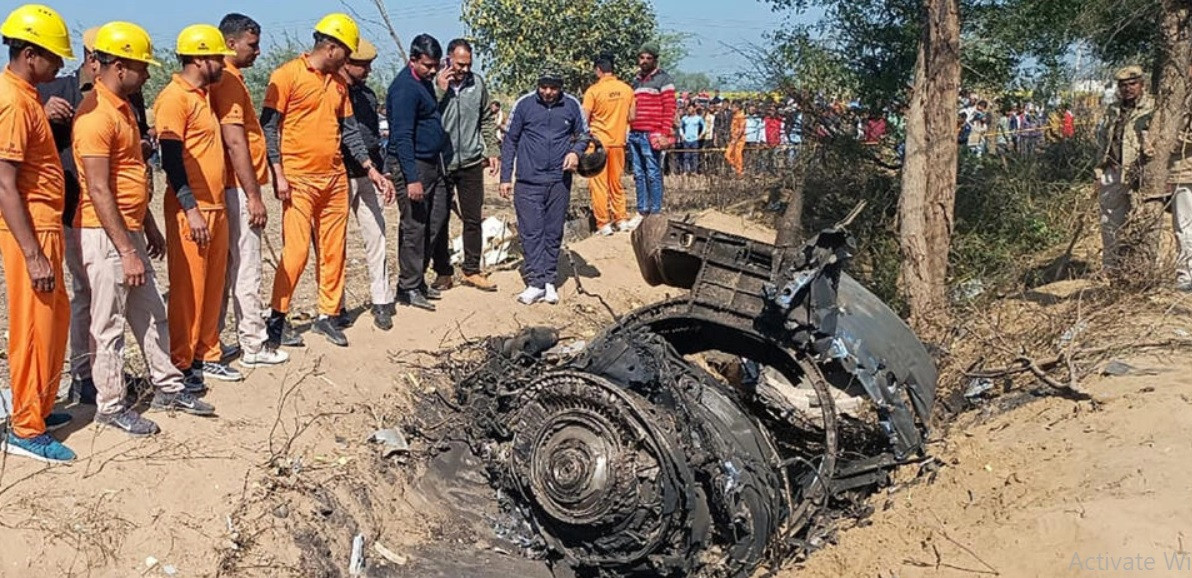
[899,0,961,332]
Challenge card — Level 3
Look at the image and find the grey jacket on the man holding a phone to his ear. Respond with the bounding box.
[435,73,501,170]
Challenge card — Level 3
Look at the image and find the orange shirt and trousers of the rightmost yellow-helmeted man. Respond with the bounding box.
[265,55,352,316]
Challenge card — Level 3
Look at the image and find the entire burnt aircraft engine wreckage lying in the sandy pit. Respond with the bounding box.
[405,217,937,577]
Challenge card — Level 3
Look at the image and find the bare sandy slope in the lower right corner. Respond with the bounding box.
[781,350,1192,578]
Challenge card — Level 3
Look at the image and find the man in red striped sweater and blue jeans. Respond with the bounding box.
[627,43,676,230]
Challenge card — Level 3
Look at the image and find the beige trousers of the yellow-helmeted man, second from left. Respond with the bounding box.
[80,229,182,414]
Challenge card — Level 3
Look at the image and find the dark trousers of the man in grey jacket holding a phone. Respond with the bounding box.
[434,160,484,276]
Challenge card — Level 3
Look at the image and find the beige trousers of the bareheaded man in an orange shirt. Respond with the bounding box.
[219,188,266,353]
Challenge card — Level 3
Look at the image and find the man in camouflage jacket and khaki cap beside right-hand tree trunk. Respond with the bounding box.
[1095,67,1155,272]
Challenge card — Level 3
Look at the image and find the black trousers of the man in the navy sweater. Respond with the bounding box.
[386,157,451,291]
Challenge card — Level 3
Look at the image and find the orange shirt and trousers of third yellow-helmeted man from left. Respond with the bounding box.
[154,75,228,371]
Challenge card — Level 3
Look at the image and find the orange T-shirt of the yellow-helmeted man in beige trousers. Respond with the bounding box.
[72,82,149,231]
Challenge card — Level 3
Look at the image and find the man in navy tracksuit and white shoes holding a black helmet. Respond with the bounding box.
[501,72,590,305]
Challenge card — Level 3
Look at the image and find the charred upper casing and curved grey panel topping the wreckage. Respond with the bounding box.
[623,217,938,459]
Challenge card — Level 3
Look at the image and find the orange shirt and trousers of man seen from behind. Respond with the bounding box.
[584,76,633,228]
